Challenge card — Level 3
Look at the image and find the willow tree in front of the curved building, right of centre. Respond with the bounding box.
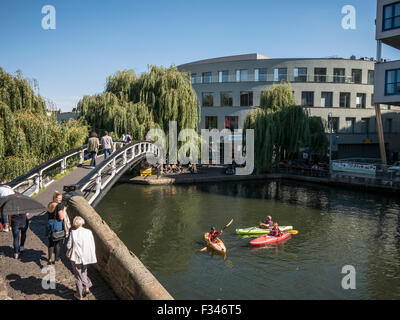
[244,84,327,172]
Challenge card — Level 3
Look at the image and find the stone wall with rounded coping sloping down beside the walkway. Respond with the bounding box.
[67,196,173,300]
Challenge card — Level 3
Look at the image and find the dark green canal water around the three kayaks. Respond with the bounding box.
[96,181,400,300]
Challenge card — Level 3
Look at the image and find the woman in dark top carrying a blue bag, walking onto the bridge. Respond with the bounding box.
[47,191,65,265]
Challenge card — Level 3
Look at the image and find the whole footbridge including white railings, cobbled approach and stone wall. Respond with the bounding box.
[0,141,173,300]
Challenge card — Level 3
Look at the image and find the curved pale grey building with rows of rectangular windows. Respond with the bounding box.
[178,53,400,158]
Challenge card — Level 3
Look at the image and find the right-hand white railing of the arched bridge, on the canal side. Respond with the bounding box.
[75,141,160,204]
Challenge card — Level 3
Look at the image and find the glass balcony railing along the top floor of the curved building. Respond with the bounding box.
[192,74,362,84]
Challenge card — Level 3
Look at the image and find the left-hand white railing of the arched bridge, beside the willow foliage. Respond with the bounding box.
[8,141,123,196]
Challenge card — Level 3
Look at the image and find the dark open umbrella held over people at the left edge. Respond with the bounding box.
[0,194,46,216]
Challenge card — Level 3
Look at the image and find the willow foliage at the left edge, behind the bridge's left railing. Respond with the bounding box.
[0,68,88,180]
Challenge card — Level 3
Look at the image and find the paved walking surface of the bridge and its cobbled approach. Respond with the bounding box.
[0,157,117,300]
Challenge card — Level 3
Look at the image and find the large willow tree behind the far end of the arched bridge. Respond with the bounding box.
[78,66,198,152]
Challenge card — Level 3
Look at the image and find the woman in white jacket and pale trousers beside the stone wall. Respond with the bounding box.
[67,216,97,300]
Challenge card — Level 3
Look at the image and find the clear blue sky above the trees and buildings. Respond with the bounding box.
[0,0,400,111]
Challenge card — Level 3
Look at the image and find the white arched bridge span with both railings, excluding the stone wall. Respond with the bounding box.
[8,141,160,207]
